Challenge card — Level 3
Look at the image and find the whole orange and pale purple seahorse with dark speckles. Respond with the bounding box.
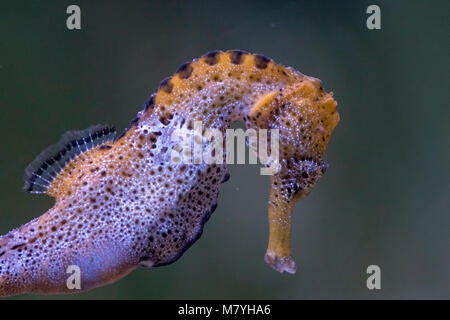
[0,50,339,296]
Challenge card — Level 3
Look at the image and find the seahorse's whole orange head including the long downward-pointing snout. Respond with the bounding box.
[246,77,339,273]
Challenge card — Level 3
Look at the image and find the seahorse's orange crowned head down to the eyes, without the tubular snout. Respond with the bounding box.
[248,76,339,198]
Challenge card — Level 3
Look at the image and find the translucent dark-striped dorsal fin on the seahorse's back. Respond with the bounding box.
[23,124,116,193]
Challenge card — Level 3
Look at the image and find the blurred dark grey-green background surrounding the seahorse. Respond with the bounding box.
[0,0,450,299]
